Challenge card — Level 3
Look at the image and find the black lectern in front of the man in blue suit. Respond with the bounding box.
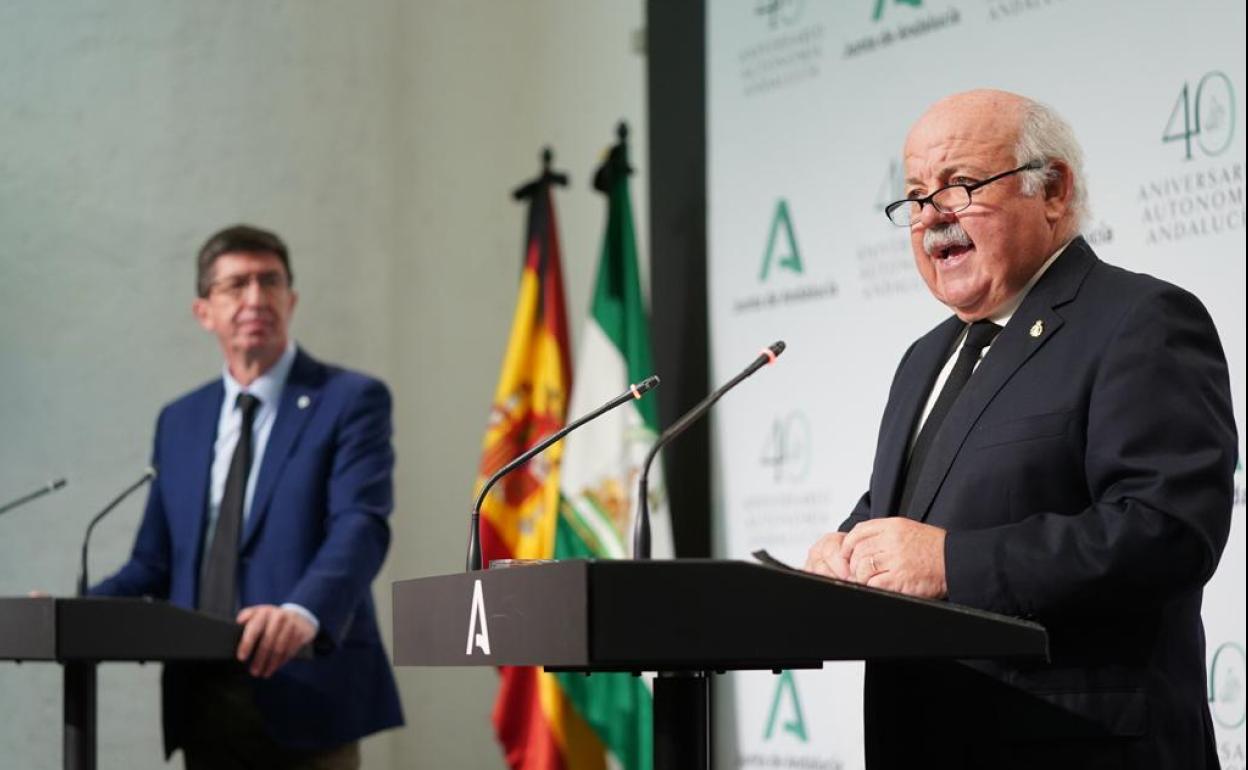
[0,598,242,770]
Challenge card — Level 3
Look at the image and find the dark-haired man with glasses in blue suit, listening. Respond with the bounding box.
[92,225,403,770]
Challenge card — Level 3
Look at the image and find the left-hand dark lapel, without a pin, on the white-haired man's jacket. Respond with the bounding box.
[872,316,965,517]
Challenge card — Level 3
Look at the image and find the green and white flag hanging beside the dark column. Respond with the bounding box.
[554,127,673,770]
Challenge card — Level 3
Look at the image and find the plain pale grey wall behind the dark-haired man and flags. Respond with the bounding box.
[0,0,645,769]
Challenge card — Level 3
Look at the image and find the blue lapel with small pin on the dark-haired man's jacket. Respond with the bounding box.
[240,349,324,552]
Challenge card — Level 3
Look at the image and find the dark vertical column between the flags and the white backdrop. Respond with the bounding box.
[645,0,711,558]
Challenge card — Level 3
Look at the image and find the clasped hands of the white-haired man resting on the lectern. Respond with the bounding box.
[805,517,948,599]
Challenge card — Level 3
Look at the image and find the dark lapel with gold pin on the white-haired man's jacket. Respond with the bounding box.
[906,237,1096,520]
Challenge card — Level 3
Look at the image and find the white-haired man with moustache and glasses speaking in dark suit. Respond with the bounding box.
[806,91,1237,770]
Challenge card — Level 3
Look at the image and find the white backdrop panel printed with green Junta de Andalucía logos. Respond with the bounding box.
[708,0,1246,769]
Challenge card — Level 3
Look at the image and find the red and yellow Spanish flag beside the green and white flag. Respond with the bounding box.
[477,160,605,770]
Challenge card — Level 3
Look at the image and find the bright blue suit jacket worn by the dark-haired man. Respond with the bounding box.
[92,351,403,751]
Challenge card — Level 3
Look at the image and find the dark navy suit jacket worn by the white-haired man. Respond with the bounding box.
[841,238,1237,769]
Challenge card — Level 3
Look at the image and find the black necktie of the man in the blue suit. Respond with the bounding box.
[200,393,260,618]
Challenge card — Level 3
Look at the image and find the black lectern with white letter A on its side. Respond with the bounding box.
[393,559,1048,770]
